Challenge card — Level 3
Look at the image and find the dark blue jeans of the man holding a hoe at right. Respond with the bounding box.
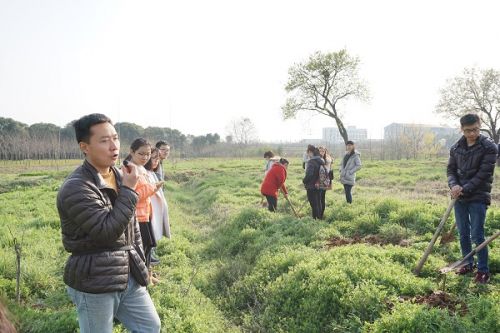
[455,200,488,273]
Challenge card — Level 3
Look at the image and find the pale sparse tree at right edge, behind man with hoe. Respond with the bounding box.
[436,68,500,143]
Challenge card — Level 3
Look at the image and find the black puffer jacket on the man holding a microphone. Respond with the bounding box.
[57,161,148,294]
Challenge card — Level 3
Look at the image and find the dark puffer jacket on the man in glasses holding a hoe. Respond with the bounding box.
[447,135,498,205]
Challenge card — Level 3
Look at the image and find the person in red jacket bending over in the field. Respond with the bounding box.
[260,158,288,212]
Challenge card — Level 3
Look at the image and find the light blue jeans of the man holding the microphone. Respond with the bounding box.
[67,276,160,333]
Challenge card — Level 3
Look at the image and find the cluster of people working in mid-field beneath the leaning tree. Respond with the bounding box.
[260,141,361,220]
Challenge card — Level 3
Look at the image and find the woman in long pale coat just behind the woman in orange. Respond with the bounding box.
[144,147,171,243]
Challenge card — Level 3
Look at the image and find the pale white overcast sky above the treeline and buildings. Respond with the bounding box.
[0,0,500,141]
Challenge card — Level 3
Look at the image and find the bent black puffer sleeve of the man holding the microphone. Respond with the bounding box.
[57,180,138,244]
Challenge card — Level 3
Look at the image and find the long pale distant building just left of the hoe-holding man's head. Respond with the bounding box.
[384,123,460,147]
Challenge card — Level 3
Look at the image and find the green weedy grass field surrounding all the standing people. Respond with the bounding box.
[0,159,500,333]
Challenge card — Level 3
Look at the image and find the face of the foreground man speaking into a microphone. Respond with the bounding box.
[80,122,120,171]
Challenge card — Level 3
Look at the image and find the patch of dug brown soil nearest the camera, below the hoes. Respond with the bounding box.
[389,290,469,316]
